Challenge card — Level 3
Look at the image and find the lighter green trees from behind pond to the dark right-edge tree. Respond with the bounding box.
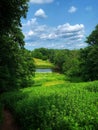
[31,48,81,81]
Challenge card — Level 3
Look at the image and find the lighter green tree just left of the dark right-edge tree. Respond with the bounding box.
[63,50,81,82]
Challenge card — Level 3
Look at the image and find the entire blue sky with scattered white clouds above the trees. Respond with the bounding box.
[21,0,98,50]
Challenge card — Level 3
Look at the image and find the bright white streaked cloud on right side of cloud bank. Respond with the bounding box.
[40,23,84,40]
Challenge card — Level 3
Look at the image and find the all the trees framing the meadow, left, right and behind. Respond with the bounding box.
[0,0,98,93]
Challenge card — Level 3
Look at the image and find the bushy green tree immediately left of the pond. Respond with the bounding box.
[16,49,35,87]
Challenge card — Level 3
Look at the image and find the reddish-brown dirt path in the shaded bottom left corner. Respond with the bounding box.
[1,109,19,130]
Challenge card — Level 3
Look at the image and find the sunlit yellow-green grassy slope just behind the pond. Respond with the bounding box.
[33,58,53,68]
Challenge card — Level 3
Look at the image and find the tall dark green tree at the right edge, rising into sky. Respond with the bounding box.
[80,25,98,81]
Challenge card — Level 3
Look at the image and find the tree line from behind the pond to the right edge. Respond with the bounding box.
[31,25,98,81]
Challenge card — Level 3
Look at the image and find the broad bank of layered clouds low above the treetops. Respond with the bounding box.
[23,19,85,49]
